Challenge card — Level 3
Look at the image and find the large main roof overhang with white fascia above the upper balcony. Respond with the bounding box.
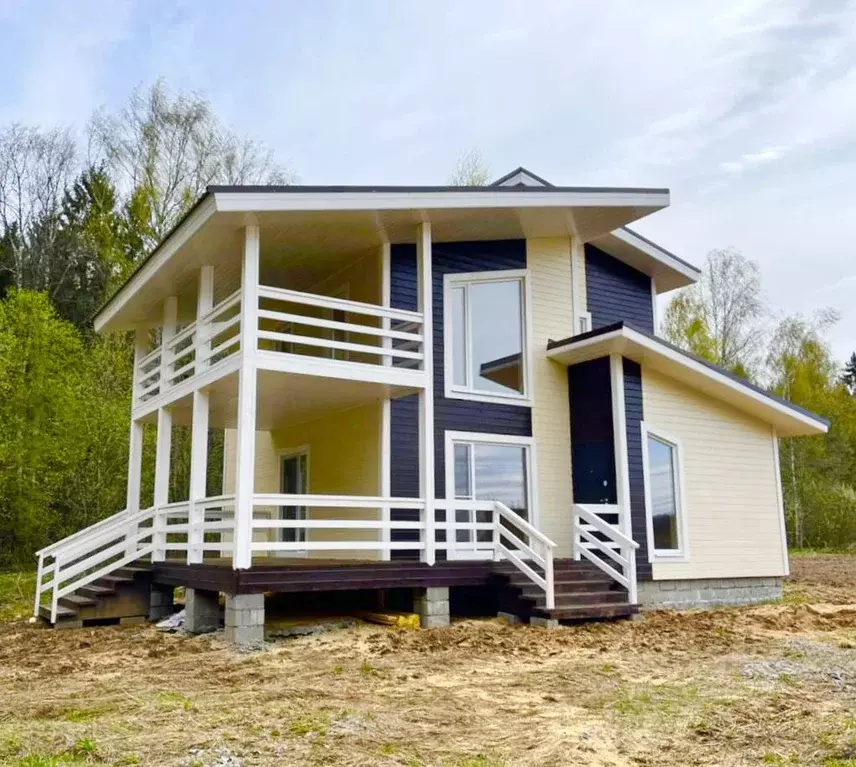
[94,186,669,332]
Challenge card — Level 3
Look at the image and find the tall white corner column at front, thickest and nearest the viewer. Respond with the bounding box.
[232,221,259,570]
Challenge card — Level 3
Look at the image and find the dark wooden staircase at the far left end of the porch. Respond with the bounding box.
[39,563,151,628]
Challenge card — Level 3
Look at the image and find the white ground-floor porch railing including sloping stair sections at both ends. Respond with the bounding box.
[34,493,555,622]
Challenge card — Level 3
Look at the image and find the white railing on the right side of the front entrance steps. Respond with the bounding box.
[573,503,639,604]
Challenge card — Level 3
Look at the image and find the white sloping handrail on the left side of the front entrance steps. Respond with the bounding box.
[493,501,556,610]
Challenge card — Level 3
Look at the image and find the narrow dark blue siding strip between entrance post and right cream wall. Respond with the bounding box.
[624,358,651,581]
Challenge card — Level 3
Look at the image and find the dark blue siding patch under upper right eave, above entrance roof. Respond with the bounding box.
[585,245,654,333]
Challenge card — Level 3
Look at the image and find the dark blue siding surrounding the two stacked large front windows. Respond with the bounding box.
[390,240,532,497]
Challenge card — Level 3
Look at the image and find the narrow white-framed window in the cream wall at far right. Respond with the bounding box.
[642,424,687,559]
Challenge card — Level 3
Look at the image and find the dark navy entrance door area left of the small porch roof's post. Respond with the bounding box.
[568,357,616,503]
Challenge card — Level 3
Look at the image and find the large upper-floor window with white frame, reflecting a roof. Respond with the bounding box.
[444,270,529,402]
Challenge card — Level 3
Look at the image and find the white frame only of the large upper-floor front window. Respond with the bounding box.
[443,269,533,407]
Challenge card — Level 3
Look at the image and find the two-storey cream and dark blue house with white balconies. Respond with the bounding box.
[36,168,828,644]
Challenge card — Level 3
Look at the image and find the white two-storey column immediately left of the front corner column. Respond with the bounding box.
[187,266,214,564]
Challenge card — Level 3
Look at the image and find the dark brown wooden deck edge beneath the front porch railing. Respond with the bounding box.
[152,558,494,594]
